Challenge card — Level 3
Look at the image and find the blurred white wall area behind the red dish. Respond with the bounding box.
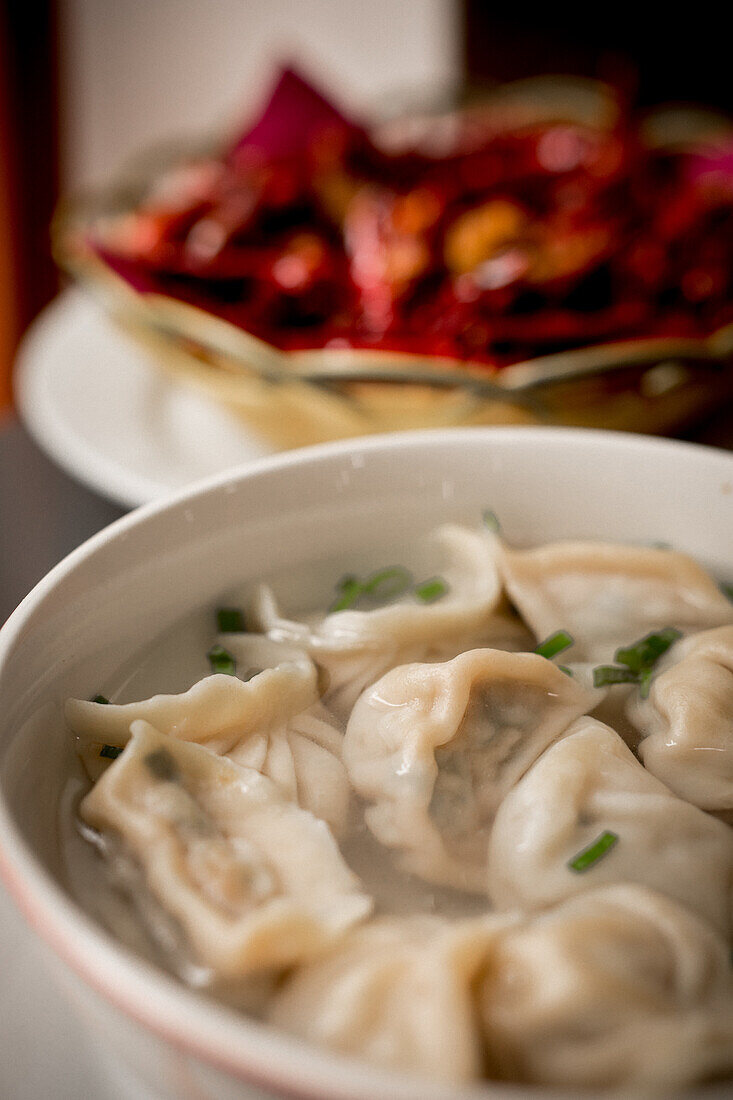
[61,0,459,190]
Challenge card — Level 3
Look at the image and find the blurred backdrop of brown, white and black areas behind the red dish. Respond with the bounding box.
[0,0,733,408]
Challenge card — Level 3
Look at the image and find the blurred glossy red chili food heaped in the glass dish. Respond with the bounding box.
[82,70,733,367]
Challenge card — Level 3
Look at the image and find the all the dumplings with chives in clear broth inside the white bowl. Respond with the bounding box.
[66,521,733,1093]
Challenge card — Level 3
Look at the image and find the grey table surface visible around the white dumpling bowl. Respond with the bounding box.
[0,406,733,1100]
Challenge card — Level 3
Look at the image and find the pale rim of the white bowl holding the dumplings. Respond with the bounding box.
[0,426,733,1100]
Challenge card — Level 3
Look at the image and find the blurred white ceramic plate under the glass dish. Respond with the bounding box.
[15,289,272,507]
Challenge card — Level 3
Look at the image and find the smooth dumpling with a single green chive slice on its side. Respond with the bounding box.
[489,717,733,935]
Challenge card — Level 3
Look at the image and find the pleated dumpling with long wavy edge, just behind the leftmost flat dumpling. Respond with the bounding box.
[66,635,350,833]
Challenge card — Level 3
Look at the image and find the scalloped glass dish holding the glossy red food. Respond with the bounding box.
[54,78,733,448]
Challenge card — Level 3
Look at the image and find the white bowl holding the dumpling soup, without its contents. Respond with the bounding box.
[0,428,733,1100]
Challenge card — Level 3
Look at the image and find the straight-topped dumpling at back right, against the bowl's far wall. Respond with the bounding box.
[497,534,733,661]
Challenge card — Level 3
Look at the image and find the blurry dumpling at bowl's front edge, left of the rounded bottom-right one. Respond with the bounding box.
[269,916,508,1085]
